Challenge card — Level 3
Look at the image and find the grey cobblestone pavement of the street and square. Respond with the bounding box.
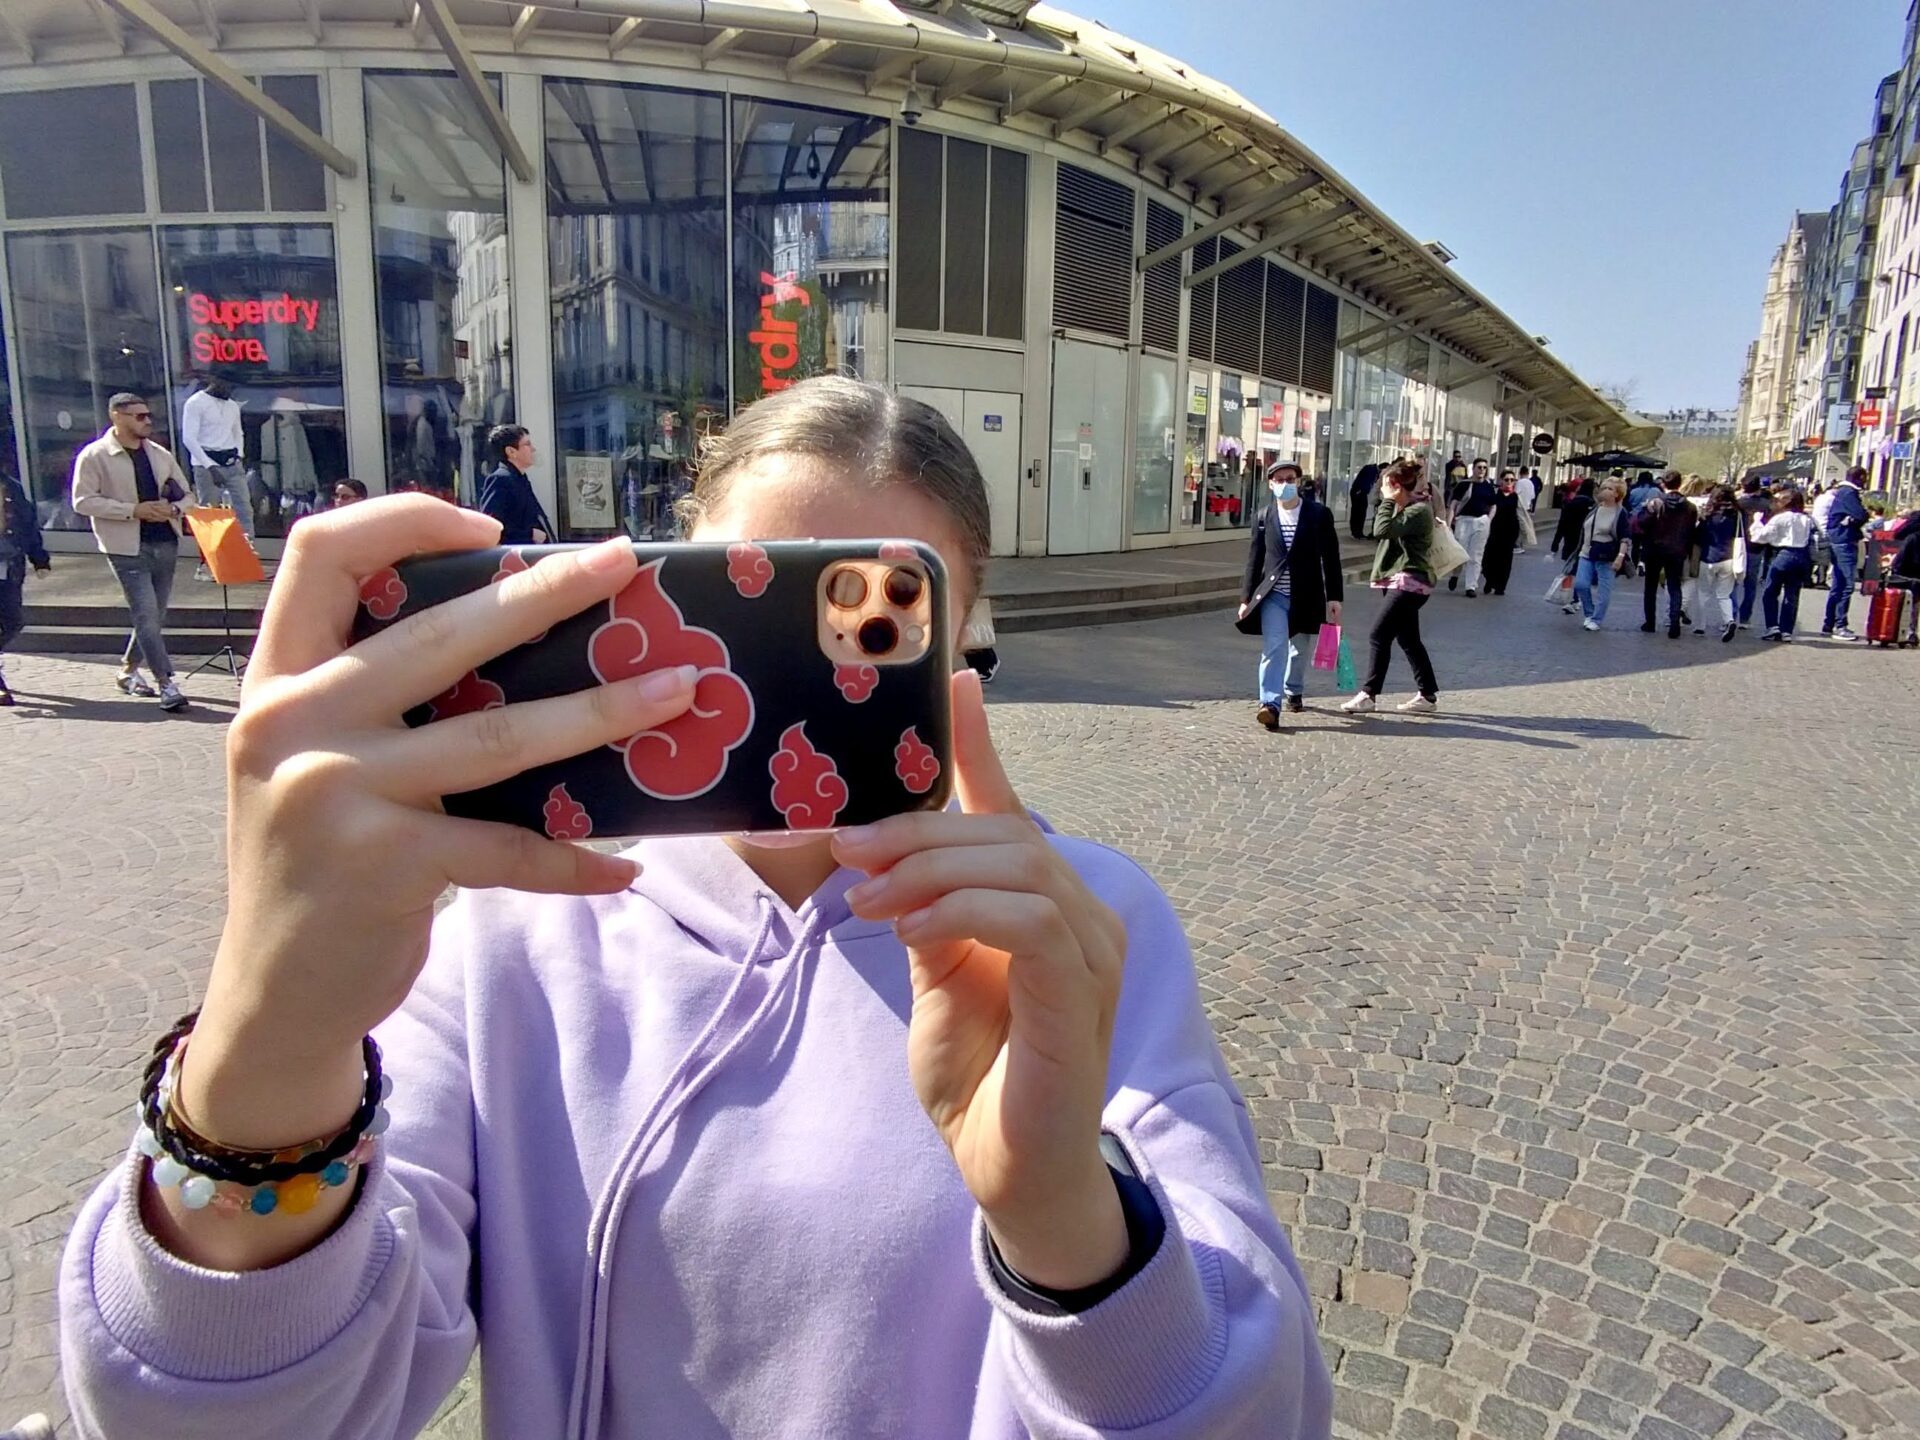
[0,561,1920,1440]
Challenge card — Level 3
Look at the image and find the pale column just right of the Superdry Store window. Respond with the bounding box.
[321,69,388,493]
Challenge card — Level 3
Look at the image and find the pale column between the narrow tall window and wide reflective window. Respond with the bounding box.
[503,75,563,524]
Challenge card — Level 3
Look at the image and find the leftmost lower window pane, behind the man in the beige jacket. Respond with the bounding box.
[6,228,173,530]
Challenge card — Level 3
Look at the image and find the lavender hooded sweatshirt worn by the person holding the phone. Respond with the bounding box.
[60,839,1332,1440]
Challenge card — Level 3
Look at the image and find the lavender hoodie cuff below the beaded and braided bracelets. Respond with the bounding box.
[88,1150,394,1382]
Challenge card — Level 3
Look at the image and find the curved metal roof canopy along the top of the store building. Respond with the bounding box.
[0,0,1661,447]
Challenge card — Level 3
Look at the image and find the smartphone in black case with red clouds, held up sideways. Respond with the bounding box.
[353,540,952,841]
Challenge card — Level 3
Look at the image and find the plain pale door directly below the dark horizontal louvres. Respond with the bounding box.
[1046,340,1127,555]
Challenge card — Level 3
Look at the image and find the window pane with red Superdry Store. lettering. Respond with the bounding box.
[159,225,348,538]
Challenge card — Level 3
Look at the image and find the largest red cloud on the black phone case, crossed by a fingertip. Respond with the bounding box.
[588,561,753,801]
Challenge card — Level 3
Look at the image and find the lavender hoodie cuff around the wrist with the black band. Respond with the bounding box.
[973,1181,1227,1430]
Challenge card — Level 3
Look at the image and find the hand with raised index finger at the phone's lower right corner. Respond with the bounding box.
[833,672,1127,1290]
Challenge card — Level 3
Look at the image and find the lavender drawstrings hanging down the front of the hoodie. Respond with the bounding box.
[566,895,822,1440]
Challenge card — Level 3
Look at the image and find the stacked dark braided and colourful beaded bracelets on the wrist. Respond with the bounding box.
[136,1012,394,1215]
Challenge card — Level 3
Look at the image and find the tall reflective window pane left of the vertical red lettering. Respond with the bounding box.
[545,81,728,540]
